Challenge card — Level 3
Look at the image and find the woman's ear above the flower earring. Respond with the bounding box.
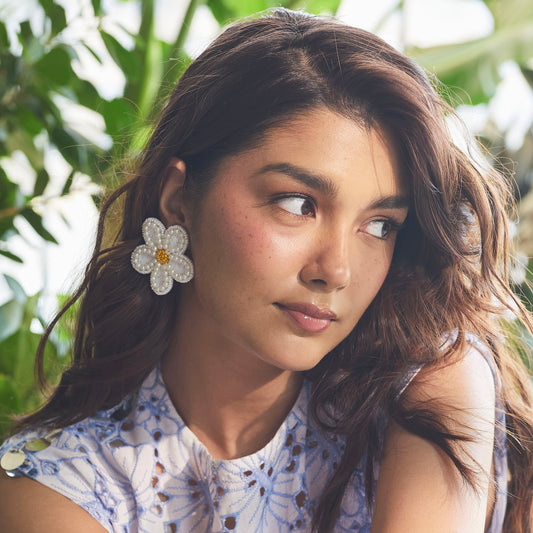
[159,157,187,226]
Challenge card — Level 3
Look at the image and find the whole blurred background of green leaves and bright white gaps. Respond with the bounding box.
[0,0,533,437]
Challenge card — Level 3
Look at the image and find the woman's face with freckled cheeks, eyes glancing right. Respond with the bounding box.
[181,108,407,370]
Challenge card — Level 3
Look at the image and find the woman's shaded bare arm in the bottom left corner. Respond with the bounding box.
[0,469,107,533]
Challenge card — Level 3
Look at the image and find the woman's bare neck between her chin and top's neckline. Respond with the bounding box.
[162,298,302,459]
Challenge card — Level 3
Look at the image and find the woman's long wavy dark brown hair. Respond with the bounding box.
[16,10,533,532]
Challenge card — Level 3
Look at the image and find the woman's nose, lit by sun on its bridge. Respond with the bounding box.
[299,227,351,292]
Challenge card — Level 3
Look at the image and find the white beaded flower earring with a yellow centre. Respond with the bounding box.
[131,217,194,296]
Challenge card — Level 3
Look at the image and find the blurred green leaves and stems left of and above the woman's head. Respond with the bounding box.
[0,0,340,438]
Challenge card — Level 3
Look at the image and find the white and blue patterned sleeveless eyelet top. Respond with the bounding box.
[0,354,507,533]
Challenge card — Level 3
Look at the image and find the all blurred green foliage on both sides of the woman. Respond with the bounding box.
[0,0,533,437]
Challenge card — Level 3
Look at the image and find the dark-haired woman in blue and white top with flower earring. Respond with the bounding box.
[0,10,533,533]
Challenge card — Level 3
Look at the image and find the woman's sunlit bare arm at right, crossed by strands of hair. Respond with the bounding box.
[371,348,495,533]
